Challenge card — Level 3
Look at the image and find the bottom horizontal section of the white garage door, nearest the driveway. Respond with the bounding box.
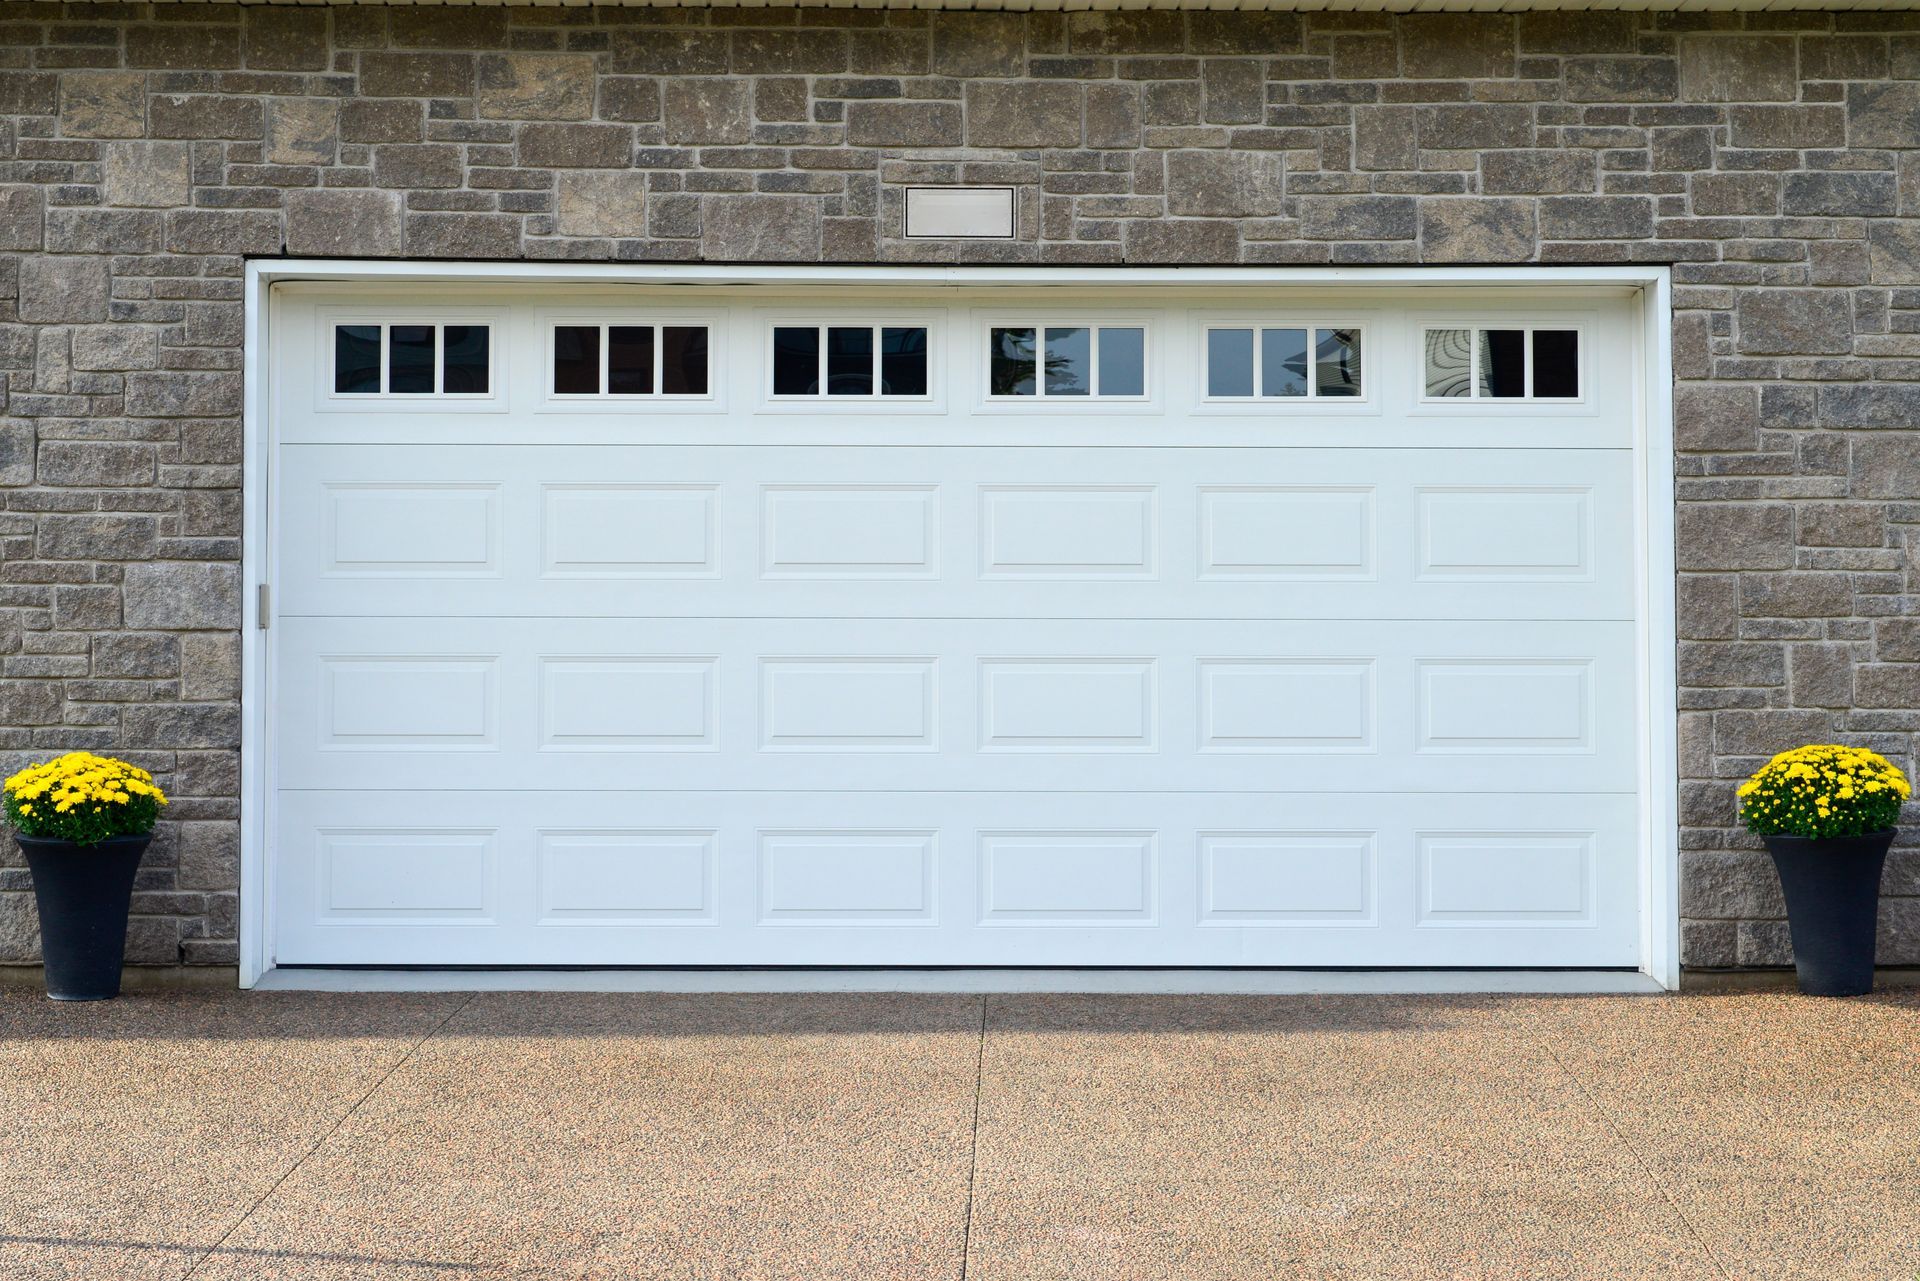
[278,791,1638,964]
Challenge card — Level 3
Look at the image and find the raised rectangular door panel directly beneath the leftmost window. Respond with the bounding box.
[321,484,499,578]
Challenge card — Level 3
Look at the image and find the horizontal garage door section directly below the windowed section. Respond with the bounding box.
[280,446,1634,618]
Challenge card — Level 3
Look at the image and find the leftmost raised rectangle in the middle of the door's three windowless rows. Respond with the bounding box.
[319,657,497,751]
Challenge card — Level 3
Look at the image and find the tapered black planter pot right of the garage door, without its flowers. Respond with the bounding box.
[1764,828,1893,997]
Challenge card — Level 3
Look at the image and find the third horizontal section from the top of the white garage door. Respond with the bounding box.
[280,618,1636,791]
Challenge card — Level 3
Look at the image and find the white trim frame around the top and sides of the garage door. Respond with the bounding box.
[238,259,1680,989]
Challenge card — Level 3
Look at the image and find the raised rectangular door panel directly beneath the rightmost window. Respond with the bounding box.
[1417,486,1594,582]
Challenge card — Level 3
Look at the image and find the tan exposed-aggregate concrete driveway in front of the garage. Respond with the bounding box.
[0,991,1920,1281]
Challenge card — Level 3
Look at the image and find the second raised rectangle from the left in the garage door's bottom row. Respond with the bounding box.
[540,832,714,924]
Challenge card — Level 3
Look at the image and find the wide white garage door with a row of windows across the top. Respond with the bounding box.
[269,286,1645,966]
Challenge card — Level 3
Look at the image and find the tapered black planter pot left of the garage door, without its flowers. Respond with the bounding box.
[17,835,154,1001]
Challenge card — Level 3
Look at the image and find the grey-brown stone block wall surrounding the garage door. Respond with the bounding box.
[0,4,1920,966]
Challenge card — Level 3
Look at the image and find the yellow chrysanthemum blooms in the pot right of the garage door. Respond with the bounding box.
[1740,743,1912,839]
